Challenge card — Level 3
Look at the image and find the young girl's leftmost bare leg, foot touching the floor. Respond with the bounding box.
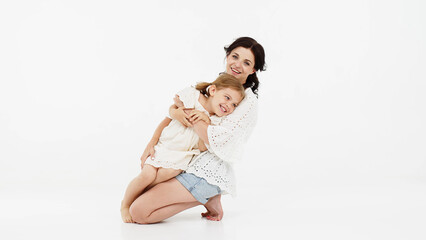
[121,164,157,223]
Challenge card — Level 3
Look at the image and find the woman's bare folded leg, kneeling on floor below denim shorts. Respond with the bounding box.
[130,178,201,224]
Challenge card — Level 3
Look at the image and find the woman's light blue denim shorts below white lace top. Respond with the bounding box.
[176,172,221,204]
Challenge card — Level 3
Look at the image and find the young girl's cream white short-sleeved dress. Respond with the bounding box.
[145,87,220,170]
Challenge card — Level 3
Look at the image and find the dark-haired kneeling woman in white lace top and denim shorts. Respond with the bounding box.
[130,37,265,224]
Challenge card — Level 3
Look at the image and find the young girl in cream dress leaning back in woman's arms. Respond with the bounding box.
[121,73,245,222]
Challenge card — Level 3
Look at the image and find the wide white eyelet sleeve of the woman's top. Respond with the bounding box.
[207,90,257,162]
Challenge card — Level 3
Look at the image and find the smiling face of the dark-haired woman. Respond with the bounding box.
[226,47,256,84]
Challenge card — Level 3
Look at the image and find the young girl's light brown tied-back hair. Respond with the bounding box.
[195,73,245,99]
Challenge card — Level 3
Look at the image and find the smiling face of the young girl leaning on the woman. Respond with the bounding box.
[209,85,243,117]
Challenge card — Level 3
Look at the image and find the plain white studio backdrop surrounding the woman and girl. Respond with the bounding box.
[0,0,426,239]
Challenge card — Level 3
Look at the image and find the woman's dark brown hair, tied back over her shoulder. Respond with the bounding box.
[224,37,266,95]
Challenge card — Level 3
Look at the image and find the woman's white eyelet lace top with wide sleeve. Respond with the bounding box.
[186,88,257,195]
